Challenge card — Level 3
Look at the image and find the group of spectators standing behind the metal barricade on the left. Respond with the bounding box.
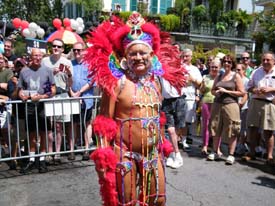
[0,39,97,173]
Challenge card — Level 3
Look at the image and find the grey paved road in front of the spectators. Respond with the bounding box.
[0,138,275,206]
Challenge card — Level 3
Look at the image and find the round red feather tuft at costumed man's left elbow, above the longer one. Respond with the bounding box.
[93,115,118,142]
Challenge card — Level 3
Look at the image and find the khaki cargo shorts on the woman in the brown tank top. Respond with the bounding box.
[209,102,241,141]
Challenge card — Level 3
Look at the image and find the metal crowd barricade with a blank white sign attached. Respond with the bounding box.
[0,96,101,162]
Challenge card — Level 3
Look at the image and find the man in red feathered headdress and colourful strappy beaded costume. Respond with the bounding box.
[86,12,185,205]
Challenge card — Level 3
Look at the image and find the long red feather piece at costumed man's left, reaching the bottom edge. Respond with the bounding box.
[90,147,118,206]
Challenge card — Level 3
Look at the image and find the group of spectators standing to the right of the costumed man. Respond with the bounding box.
[163,43,275,169]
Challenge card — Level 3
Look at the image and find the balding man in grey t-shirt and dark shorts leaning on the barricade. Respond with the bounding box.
[18,48,56,173]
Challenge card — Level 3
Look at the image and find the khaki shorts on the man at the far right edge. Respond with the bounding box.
[247,99,275,130]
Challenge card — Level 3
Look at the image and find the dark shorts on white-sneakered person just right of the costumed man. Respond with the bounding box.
[161,95,186,129]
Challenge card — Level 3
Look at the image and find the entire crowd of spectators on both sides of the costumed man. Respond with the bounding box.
[0,34,275,173]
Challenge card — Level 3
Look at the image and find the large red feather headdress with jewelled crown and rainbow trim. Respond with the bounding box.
[85,12,186,97]
